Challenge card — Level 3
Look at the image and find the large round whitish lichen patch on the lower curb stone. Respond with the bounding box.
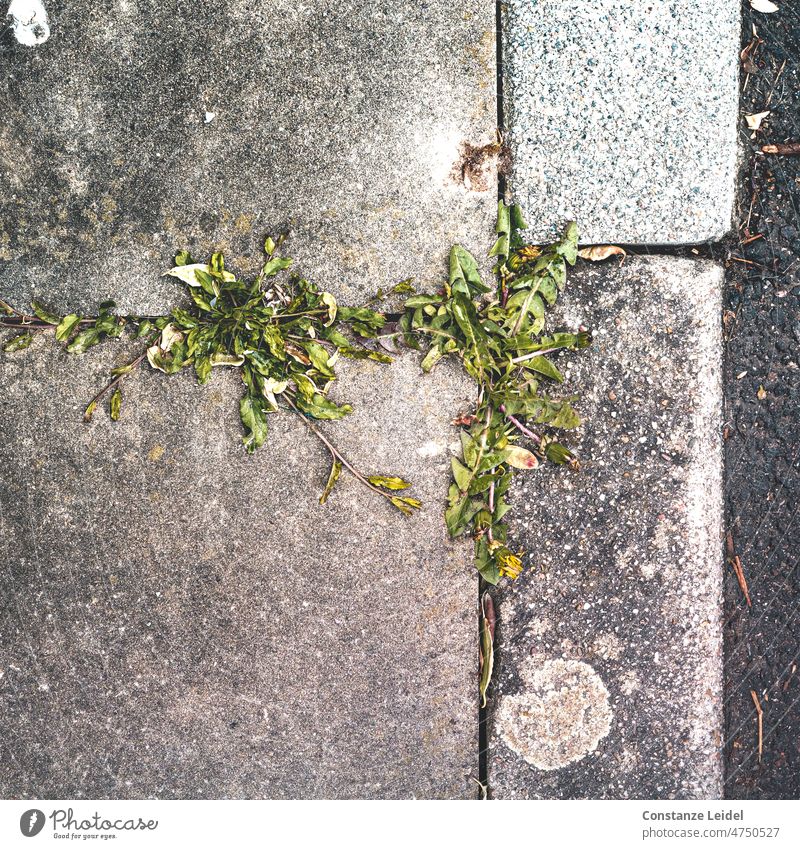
[496,659,613,770]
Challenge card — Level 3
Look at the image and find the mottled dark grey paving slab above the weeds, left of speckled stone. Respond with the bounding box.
[0,0,497,313]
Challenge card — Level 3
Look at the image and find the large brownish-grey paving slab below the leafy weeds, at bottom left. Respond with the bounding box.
[0,339,478,799]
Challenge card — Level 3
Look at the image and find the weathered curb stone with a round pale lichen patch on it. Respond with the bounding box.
[488,258,722,799]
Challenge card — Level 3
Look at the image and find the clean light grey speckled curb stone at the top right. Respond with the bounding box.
[503,0,740,244]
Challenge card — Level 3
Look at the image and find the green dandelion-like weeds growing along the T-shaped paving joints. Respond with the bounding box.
[0,202,589,584]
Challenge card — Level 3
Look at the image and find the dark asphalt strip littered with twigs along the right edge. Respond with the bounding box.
[720,0,800,799]
